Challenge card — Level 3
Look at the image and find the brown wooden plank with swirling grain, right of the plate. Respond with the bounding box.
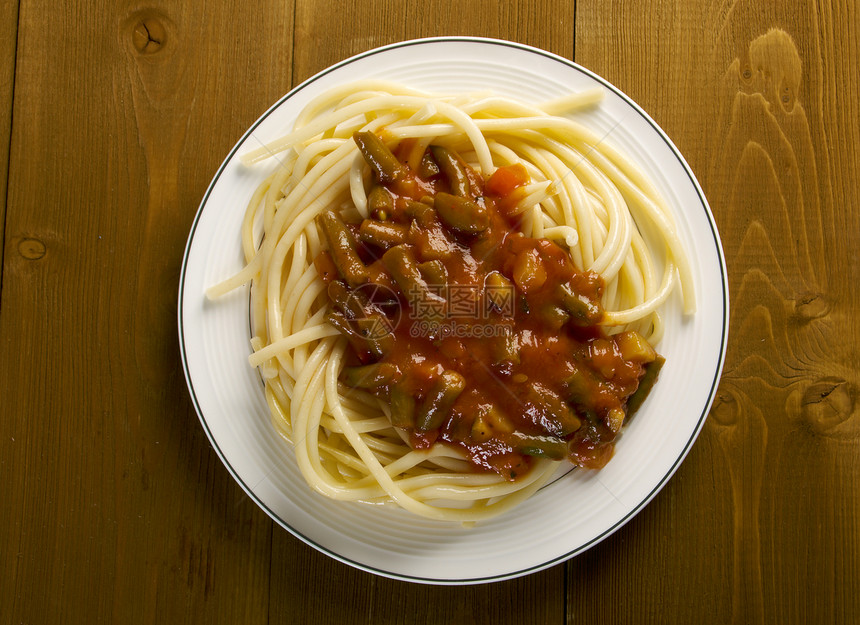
[568,0,860,623]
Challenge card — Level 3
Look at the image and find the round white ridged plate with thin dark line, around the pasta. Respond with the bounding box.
[179,38,728,584]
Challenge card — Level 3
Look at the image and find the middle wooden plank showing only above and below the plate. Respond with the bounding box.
[271,0,573,625]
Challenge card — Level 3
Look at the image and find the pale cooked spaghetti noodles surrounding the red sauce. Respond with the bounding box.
[208,80,695,523]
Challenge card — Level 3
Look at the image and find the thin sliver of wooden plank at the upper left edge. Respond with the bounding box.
[0,0,18,276]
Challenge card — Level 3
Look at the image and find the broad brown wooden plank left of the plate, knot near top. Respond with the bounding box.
[0,0,292,623]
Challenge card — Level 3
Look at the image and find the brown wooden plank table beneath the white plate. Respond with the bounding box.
[0,0,860,624]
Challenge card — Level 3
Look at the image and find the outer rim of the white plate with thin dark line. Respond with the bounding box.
[177,36,730,585]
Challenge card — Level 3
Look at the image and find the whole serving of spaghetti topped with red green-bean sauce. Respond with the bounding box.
[207,80,695,523]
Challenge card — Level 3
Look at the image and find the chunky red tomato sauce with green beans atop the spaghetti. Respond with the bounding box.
[316,133,663,480]
